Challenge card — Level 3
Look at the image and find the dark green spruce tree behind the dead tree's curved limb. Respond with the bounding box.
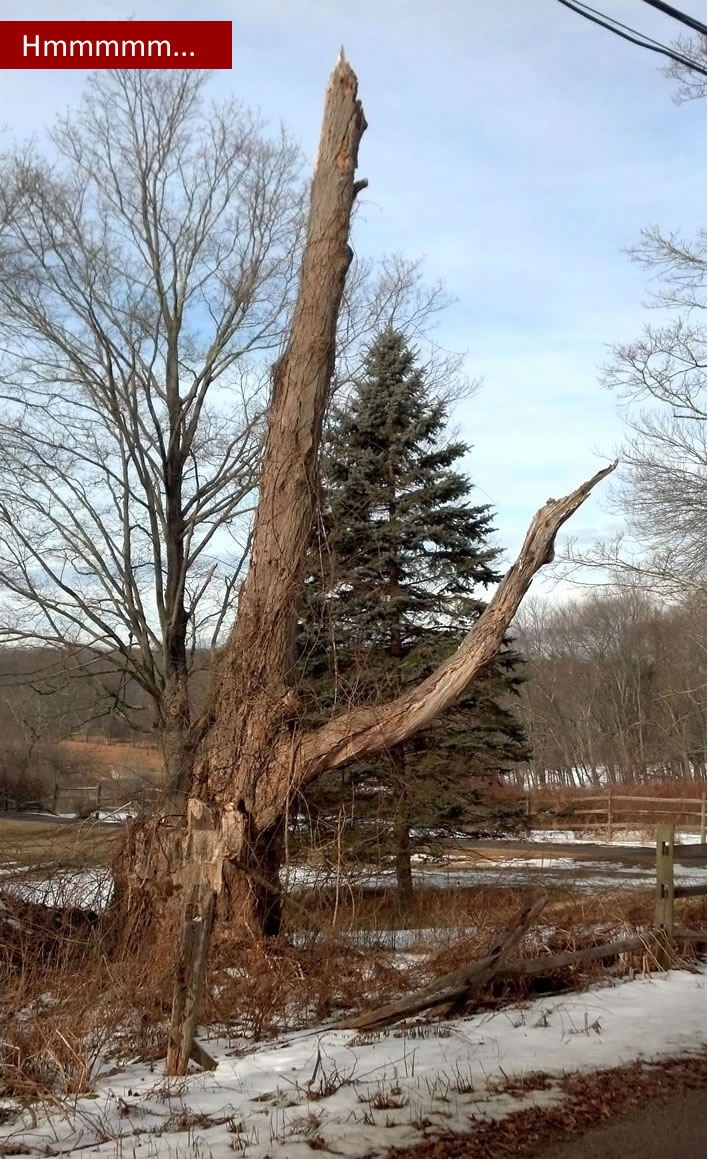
[298,329,528,896]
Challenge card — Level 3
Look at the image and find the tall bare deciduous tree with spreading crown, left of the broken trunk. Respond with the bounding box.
[0,70,464,790]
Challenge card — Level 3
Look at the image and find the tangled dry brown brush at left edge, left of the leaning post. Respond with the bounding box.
[0,871,173,1104]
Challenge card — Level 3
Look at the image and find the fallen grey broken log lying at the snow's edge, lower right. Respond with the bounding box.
[337,894,548,1030]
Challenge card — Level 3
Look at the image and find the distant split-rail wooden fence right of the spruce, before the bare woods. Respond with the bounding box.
[526,789,706,842]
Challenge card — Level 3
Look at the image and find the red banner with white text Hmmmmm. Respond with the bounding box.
[0,20,231,68]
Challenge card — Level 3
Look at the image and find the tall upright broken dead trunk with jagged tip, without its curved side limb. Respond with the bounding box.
[162,53,366,1075]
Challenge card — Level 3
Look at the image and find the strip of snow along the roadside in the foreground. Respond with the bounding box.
[0,971,706,1158]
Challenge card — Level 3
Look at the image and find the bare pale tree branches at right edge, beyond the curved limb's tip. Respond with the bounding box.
[559,227,706,595]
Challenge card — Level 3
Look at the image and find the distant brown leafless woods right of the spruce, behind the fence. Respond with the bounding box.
[516,585,706,785]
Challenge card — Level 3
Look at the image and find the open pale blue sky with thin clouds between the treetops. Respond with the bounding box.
[0,0,706,587]
